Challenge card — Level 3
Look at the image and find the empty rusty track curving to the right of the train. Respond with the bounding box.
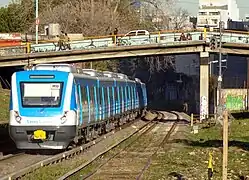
[58,112,180,180]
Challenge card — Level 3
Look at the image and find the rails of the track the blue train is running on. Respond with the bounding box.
[0,112,158,180]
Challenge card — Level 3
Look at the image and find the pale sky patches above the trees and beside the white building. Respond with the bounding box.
[0,0,249,18]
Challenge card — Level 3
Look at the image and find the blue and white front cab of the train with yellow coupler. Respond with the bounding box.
[9,71,77,149]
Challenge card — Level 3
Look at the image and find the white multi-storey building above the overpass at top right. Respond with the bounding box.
[197,0,239,28]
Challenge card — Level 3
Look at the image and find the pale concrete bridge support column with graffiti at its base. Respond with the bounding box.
[200,52,209,121]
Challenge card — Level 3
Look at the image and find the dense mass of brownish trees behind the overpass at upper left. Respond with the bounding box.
[0,0,160,33]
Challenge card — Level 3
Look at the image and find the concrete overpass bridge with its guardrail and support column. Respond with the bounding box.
[0,31,249,117]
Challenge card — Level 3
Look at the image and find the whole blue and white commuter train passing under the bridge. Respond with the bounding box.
[9,64,147,150]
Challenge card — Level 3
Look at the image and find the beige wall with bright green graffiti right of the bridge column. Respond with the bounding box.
[222,89,247,111]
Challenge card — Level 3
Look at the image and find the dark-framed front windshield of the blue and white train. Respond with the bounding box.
[21,82,63,107]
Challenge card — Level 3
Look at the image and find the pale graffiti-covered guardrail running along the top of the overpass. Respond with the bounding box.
[0,30,249,56]
